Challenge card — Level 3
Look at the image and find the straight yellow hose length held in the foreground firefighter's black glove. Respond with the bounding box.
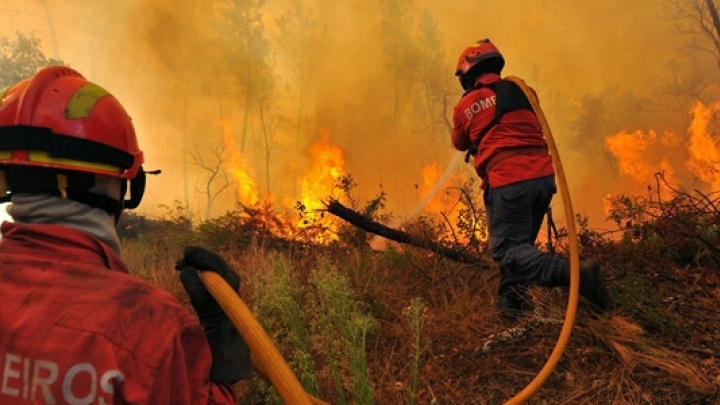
[200,271,329,405]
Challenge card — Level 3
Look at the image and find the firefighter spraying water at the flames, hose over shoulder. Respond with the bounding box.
[451,39,609,319]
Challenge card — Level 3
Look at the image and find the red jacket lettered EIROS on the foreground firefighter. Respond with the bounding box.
[0,222,236,405]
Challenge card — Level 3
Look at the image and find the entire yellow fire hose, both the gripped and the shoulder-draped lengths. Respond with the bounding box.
[200,76,580,405]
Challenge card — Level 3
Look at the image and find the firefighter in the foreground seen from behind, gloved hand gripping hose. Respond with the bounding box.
[0,66,251,405]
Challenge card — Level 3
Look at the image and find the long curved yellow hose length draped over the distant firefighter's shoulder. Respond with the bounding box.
[505,76,580,405]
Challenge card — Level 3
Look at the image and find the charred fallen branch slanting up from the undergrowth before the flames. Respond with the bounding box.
[325,199,490,267]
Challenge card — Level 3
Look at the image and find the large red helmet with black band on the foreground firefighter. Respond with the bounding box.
[0,66,143,180]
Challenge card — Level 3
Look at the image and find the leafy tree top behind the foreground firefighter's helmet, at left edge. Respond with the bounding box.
[0,31,64,88]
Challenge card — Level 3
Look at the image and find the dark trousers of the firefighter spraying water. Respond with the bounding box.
[483,176,570,295]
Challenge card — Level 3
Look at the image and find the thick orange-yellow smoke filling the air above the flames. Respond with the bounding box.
[0,0,718,226]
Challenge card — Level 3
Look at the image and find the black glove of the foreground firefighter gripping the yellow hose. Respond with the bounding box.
[175,246,252,383]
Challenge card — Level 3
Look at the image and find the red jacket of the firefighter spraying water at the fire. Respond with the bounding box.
[452,73,555,187]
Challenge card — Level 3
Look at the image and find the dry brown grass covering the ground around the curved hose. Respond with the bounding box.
[125,232,720,405]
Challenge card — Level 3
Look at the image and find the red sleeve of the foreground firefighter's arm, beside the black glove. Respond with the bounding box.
[150,324,237,405]
